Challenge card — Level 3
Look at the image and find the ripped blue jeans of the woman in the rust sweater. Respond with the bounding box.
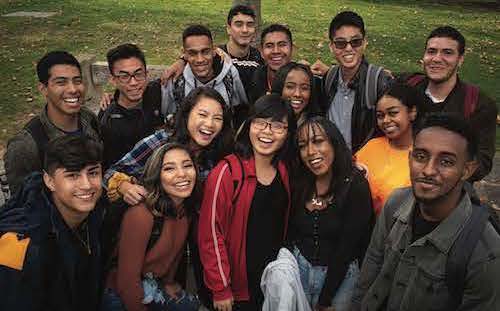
[101,276,200,311]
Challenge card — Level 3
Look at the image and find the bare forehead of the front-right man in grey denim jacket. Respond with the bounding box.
[414,126,467,156]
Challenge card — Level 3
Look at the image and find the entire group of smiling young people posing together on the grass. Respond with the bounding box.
[0,6,500,311]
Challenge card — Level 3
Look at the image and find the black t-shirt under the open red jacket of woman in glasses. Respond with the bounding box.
[246,172,288,305]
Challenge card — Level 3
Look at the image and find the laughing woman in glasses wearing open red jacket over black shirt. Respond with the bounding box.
[198,94,296,311]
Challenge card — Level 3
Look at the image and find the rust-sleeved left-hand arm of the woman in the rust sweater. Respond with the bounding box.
[116,205,153,311]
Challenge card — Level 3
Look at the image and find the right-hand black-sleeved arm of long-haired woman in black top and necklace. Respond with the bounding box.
[318,174,374,307]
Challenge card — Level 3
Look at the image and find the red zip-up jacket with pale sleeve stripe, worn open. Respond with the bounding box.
[198,154,291,301]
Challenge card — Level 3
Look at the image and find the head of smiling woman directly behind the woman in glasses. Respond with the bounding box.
[271,62,319,124]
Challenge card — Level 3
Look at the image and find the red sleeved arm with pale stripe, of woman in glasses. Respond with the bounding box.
[198,162,233,302]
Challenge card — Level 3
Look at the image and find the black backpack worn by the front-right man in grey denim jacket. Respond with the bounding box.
[384,189,500,311]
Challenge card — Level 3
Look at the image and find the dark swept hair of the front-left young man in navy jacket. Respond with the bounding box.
[43,135,103,174]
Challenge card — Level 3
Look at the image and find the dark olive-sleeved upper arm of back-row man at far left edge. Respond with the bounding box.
[4,130,42,194]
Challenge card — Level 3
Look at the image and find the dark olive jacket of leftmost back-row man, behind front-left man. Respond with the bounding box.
[4,107,100,193]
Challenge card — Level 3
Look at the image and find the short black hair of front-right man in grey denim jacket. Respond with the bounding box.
[413,112,479,160]
